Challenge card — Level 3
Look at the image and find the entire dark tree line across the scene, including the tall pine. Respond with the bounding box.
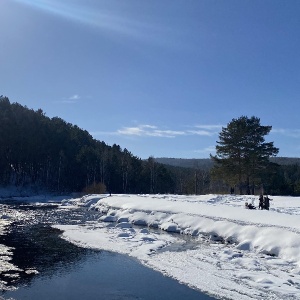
[0,96,300,195]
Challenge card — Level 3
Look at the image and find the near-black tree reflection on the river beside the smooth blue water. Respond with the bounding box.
[4,224,92,284]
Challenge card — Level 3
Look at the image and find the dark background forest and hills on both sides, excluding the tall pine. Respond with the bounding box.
[0,96,300,196]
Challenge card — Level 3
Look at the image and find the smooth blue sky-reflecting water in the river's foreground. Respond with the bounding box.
[4,248,218,300]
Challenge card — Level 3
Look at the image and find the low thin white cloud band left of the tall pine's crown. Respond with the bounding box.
[92,124,220,138]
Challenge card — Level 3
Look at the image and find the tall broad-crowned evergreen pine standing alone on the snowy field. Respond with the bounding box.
[211,116,279,194]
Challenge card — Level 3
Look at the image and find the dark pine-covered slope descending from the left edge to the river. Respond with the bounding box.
[0,96,175,193]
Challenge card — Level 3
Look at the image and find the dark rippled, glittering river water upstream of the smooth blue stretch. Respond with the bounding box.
[0,201,95,289]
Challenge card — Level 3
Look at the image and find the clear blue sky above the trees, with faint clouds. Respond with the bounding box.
[0,0,300,158]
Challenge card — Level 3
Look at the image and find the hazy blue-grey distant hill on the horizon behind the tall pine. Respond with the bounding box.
[155,157,300,170]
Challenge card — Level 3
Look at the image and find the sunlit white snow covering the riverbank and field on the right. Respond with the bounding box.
[56,195,300,299]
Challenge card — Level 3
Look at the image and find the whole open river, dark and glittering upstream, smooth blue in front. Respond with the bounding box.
[0,202,215,300]
